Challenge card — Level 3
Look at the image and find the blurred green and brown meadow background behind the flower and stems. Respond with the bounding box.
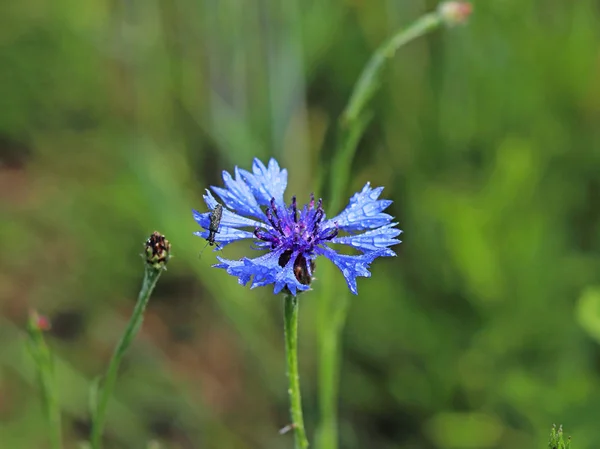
[0,0,600,449]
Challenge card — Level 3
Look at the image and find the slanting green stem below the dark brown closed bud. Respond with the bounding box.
[91,265,163,449]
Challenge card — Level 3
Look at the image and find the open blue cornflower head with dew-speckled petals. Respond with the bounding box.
[193,159,402,295]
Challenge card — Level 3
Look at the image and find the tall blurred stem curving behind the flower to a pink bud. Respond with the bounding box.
[317,11,443,449]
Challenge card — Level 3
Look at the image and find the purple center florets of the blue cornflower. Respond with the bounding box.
[254,194,338,260]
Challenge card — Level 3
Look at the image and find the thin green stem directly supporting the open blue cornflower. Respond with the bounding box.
[284,294,308,449]
